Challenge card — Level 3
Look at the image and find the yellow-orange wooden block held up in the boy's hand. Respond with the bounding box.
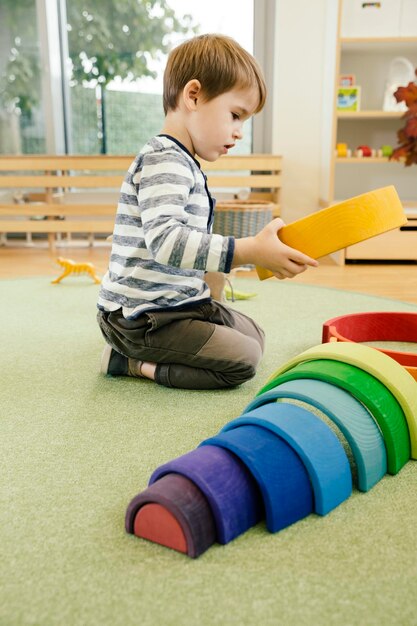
[256,185,407,280]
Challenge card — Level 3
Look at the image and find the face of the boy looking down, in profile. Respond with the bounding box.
[188,88,259,161]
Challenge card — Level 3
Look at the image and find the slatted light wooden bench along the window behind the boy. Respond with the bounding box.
[0,155,282,248]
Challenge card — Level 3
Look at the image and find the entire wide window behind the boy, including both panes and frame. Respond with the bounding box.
[0,0,260,154]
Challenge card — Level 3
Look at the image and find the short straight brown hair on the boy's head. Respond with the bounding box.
[163,35,266,115]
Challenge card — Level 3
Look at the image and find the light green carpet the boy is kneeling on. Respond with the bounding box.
[0,277,417,626]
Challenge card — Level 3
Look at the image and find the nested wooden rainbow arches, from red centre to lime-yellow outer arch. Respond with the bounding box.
[125,338,417,558]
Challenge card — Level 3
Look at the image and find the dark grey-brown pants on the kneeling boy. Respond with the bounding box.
[97,300,264,389]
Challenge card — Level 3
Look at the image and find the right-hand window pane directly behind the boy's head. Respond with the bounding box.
[66,0,253,154]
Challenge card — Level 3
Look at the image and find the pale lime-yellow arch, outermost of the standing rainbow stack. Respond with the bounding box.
[267,342,417,459]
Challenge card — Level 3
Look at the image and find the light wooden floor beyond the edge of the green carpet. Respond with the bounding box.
[0,242,417,304]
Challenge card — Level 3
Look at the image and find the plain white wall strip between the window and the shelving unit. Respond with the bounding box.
[271,0,330,222]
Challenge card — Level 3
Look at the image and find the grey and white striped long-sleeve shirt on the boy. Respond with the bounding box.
[98,135,234,319]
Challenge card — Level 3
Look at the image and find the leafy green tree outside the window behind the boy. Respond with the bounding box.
[67,0,197,153]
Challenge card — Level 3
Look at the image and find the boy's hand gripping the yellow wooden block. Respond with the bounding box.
[232,217,318,280]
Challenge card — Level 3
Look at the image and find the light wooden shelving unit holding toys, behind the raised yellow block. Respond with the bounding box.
[320,0,417,263]
